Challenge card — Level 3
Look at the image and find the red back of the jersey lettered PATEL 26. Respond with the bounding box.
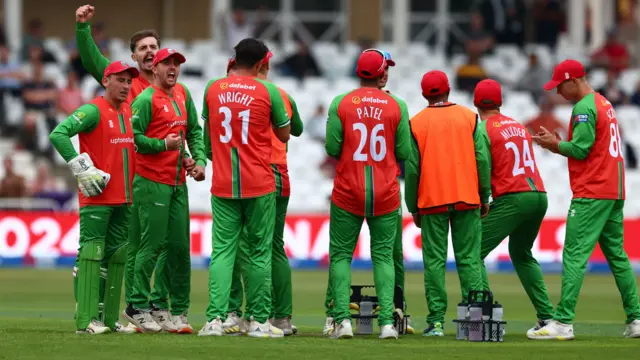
[327,88,402,216]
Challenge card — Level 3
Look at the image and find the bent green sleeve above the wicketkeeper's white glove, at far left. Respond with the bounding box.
[49,104,100,162]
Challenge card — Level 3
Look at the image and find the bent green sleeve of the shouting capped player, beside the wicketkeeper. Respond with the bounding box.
[131,90,167,154]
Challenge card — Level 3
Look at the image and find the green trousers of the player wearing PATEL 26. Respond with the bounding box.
[329,202,398,326]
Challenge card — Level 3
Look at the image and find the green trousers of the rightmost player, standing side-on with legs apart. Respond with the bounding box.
[553,198,640,324]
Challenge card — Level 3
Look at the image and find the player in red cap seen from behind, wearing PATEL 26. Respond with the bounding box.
[325,49,409,339]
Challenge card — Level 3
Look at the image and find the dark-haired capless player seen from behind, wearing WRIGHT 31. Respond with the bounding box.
[198,38,290,338]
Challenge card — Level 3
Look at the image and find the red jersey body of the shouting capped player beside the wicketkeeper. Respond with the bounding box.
[136,83,188,186]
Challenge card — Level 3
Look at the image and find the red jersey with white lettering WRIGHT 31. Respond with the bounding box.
[203,75,289,199]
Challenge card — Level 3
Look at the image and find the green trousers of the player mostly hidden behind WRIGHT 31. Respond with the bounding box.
[229,196,293,319]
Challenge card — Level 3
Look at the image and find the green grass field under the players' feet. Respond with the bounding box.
[0,269,640,360]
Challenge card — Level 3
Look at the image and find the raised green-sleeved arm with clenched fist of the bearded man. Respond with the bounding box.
[76,5,109,85]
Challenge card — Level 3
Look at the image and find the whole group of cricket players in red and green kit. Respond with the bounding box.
[50,5,640,340]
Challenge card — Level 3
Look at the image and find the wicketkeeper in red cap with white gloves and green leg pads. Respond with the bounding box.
[49,61,138,334]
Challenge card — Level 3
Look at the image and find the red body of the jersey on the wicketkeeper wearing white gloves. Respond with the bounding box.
[78,96,135,207]
